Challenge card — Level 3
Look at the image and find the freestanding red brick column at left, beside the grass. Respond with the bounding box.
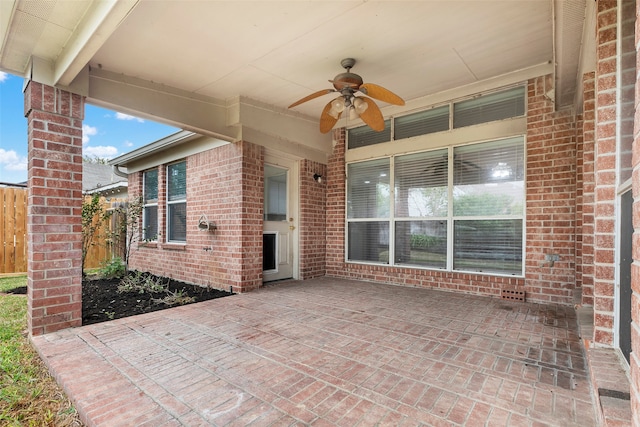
[24,81,84,335]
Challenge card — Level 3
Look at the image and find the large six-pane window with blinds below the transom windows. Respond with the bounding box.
[347,137,525,275]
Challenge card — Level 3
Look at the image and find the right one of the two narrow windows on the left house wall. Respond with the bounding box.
[167,162,187,242]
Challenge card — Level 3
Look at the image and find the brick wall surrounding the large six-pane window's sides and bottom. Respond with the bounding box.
[327,76,582,304]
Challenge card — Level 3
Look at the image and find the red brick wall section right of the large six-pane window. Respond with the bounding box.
[525,76,577,304]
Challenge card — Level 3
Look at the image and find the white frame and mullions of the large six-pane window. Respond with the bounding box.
[344,134,526,277]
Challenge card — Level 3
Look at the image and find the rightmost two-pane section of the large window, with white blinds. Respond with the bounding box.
[453,138,525,274]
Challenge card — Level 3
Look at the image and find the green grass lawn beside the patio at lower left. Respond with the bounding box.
[0,276,80,426]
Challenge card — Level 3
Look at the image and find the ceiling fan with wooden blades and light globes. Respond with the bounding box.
[289,58,404,133]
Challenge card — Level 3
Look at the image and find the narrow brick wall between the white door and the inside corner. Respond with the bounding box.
[298,160,327,280]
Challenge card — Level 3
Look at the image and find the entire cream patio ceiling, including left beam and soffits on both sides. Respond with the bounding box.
[0,0,585,130]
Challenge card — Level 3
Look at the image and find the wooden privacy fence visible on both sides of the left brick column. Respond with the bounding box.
[0,187,126,274]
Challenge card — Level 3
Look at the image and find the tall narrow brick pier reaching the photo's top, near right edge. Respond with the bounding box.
[593,1,617,345]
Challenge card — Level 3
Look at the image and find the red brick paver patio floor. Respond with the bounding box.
[33,278,596,427]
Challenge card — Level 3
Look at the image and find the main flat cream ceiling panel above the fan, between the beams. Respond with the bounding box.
[91,0,553,117]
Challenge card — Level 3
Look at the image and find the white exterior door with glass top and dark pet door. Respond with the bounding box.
[262,159,297,282]
